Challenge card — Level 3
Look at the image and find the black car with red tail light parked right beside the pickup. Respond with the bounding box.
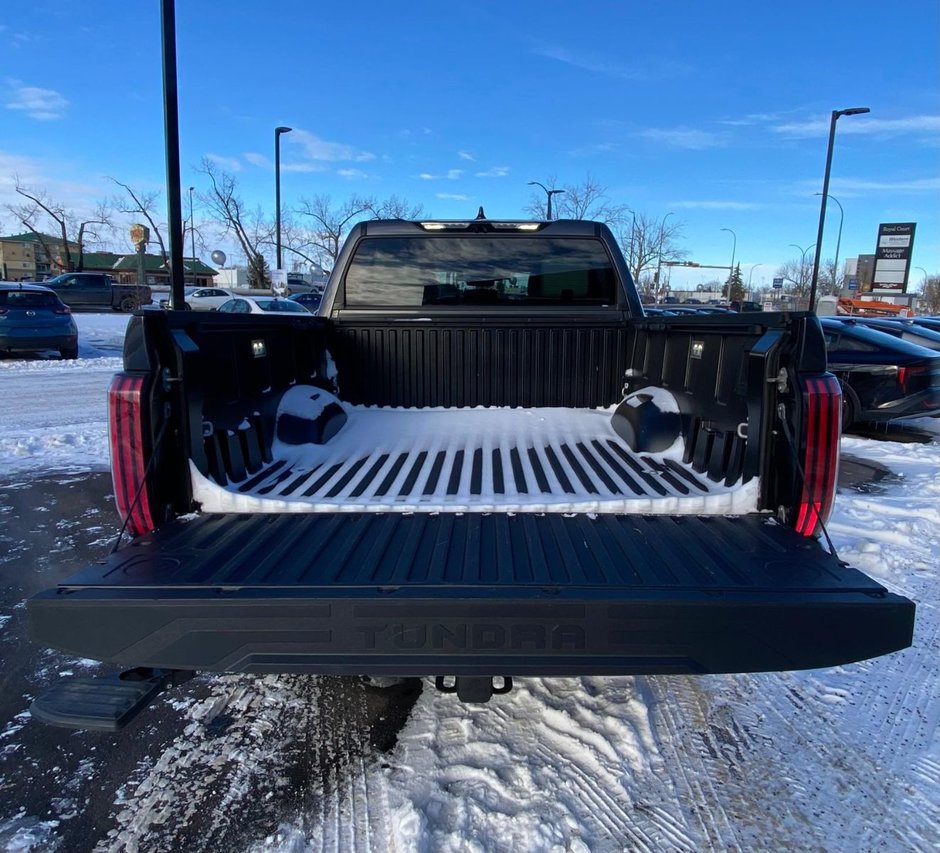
[820,317,940,429]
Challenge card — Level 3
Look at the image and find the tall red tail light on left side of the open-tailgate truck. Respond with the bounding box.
[108,373,155,536]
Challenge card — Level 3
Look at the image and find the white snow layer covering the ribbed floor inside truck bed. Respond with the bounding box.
[190,387,757,515]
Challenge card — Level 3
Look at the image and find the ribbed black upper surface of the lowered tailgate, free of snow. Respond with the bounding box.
[68,513,883,595]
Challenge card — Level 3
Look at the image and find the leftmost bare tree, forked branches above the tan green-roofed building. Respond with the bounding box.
[7,176,111,272]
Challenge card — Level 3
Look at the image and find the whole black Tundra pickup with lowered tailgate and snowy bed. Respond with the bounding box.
[29,219,914,727]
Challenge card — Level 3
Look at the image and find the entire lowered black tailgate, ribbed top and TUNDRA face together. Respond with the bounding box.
[29,513,914,676]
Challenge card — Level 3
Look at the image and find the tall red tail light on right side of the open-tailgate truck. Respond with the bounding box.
[796,376,842,536]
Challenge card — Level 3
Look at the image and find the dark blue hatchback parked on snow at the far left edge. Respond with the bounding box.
[0,284,78,359]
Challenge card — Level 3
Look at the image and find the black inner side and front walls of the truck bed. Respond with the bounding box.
[131,312,786,512]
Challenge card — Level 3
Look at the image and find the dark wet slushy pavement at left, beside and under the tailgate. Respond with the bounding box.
[0,473,421,850]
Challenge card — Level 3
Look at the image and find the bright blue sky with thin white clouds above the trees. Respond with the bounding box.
[0,0,940,285]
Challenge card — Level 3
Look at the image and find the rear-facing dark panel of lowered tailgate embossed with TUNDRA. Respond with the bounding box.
[30,589,914,676]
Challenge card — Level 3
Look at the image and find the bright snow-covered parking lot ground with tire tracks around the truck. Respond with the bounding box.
[0,315,940,853]
